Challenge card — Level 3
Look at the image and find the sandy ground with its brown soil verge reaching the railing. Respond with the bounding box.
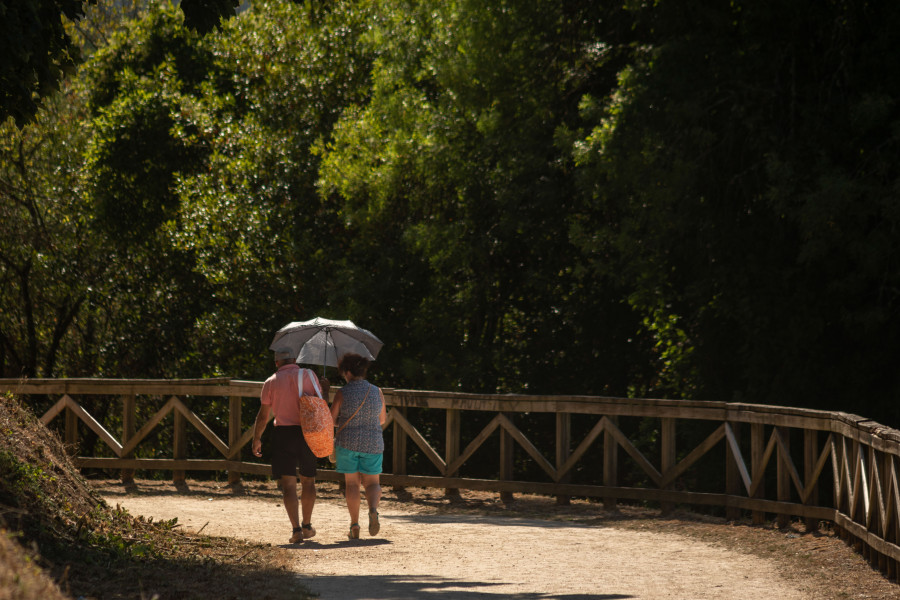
[95,481,900,600]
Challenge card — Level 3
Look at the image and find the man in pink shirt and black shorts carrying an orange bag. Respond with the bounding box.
[253,348,329,544]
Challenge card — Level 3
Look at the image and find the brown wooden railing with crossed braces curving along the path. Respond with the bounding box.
[0,379,900,579]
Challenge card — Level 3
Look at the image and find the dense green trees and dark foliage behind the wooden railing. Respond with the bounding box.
[0,0,900,425]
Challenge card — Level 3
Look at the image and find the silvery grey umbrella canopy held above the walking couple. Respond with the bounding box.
[269,317,384,367]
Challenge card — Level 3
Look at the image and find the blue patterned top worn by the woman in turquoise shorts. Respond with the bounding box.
[334,379,384,454]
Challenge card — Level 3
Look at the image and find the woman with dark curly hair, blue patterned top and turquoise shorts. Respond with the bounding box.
[331,354,387,539]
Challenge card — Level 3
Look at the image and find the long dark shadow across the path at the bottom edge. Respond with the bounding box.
[303,575,635,600]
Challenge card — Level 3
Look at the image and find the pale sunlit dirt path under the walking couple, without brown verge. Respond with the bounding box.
[99,482,900,600]
